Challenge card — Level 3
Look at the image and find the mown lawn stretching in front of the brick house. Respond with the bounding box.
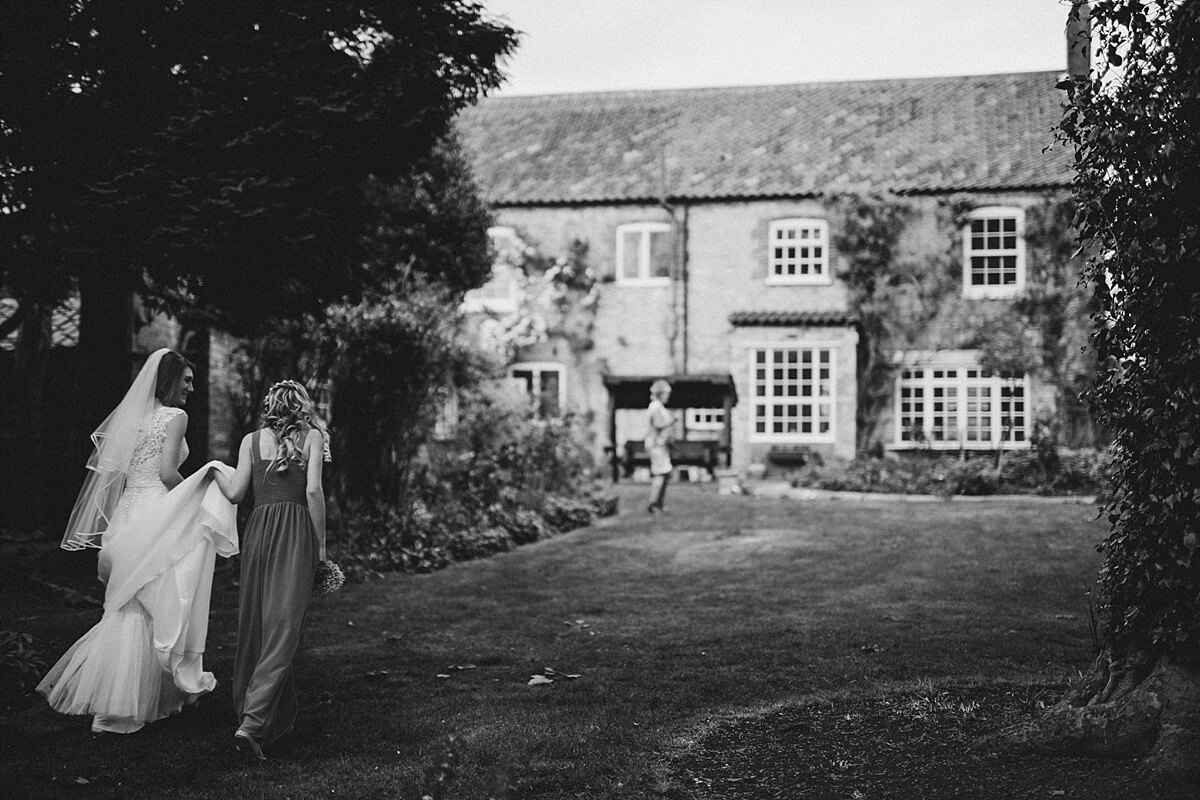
[0,487,1129,799]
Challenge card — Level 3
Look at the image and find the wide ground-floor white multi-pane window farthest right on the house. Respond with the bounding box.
[894,350,1030,450]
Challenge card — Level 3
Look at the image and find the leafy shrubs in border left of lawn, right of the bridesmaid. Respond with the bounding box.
[330,383,604,579]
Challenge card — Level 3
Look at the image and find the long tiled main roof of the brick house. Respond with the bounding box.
[458,72,1069,205]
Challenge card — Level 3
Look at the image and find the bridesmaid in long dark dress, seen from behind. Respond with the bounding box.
[217,380,326,760]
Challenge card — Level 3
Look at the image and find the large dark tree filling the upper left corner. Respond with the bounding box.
[0,0,515,417]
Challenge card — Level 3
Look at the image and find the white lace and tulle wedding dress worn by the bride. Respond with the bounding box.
[37,407,238,733]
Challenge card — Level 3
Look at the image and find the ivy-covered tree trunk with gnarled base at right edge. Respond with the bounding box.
[983,0,1200,792]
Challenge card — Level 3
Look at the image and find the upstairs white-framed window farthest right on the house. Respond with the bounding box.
[962,206,1025,297]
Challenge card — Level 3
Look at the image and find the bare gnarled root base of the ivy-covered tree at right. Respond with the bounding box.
[976,654,1200,790]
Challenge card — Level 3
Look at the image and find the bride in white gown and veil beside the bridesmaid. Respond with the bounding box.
[37,349,238,733]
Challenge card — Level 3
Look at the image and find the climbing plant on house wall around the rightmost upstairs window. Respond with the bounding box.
[833,194,1091,451]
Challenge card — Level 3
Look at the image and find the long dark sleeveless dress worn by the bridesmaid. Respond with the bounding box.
[233,431,320,744]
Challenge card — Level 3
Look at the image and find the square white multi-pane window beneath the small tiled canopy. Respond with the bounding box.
[750,344,836,443]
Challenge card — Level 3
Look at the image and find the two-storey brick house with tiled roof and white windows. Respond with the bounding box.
[460,62,1086,474]
